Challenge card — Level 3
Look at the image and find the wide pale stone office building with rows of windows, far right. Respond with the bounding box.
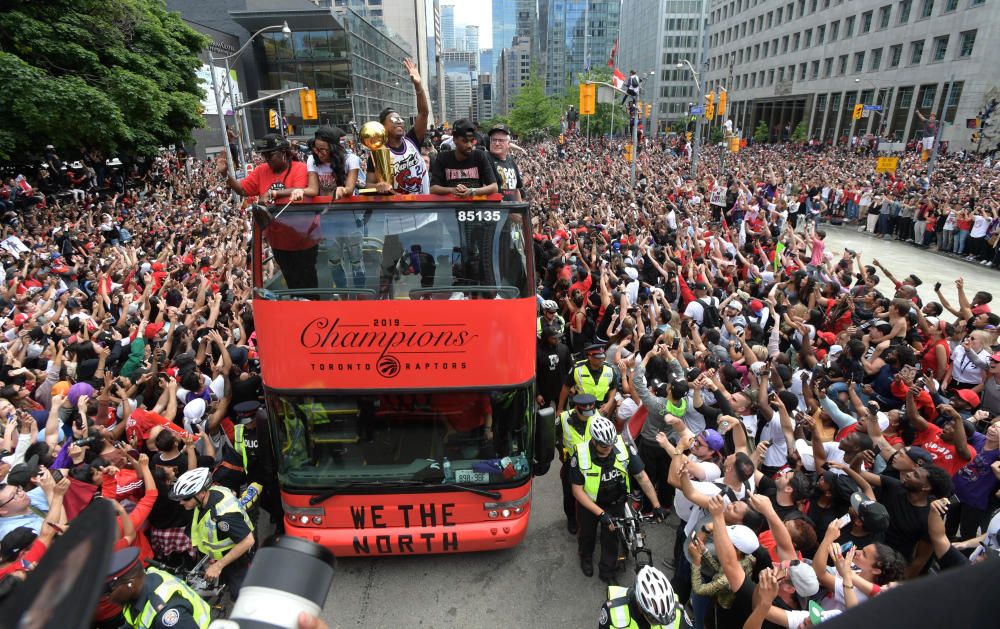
[703,0,1000,150]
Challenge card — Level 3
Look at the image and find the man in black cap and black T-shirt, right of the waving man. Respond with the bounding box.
[431,118,497,197]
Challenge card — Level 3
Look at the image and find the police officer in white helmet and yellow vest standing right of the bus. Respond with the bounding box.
[569,417,667,584]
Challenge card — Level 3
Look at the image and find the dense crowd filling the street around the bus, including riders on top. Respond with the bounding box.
[0,55,1000,628]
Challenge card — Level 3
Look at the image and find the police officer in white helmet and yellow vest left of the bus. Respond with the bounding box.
[170,467,254,598]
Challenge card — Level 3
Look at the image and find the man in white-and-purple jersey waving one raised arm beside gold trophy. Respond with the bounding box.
[361,59,431,194]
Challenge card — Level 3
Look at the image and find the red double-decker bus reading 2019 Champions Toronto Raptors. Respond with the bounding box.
[246,195,553,556]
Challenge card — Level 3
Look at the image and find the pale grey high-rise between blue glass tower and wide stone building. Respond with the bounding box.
[616,0,707,131]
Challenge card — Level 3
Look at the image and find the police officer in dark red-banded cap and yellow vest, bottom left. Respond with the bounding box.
[105,547,212,629]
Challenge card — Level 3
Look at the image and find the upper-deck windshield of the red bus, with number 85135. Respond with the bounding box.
[257,203,530,300]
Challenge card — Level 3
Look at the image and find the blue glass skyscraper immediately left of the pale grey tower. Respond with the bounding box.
[538,0,620,95]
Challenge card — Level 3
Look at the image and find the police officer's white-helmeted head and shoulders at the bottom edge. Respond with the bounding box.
[597,566,688,629]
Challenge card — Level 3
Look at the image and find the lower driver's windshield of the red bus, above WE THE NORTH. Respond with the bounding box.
[270,387,533,489]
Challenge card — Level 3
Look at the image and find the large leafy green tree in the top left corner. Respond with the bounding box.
[0,0,209,159]
